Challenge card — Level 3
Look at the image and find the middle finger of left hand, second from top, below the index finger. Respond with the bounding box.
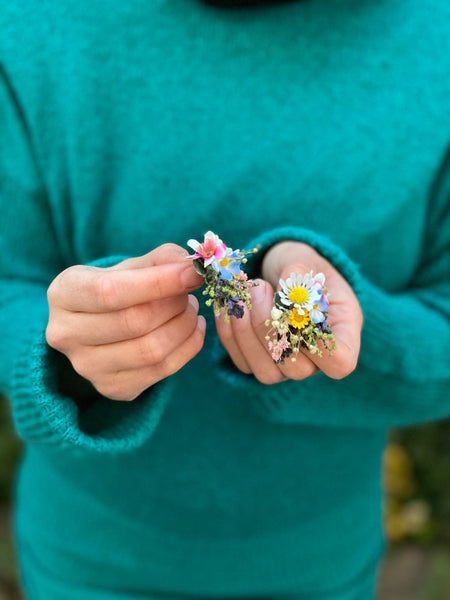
[52,294,189,352]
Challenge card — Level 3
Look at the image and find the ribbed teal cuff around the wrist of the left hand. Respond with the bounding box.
[10,257,170,452]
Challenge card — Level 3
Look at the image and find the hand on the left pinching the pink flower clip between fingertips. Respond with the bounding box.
[46,244,206,400]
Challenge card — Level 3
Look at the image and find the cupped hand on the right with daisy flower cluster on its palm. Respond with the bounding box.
[216,241,363,385]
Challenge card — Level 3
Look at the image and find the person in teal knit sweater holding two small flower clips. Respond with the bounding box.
[0,0,450,600]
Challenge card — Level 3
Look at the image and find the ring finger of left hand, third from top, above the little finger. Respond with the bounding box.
[71,296,198,380]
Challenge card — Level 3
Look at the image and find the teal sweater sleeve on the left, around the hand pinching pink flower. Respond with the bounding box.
[0,63,171,452]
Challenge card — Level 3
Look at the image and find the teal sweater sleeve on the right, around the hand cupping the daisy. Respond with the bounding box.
[216,156,450,428]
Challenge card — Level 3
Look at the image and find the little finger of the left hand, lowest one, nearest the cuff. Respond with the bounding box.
[92,317,206,401]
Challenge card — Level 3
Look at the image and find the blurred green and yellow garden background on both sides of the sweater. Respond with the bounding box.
[0,398,450,600]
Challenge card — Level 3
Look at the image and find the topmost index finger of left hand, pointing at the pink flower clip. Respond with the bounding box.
[55,260,203,313]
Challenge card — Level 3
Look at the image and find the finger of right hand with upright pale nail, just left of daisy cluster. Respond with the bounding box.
[231,280,284,385]
